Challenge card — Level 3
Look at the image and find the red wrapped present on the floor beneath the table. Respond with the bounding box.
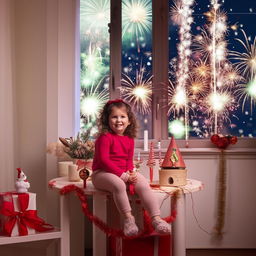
[108,235,172,256]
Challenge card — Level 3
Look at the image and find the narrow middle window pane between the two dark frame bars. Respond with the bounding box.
[121,0,152,138]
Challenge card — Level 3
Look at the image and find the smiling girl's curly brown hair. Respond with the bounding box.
[97,99,138,138]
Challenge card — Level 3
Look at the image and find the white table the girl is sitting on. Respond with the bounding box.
[49,177,203,256]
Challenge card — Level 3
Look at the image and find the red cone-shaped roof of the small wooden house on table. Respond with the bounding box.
[162,136,186,169]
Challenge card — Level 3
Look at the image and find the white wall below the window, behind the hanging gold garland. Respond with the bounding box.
[185,149,256,248]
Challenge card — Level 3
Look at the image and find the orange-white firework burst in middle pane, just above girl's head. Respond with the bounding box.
[120,67,152,114]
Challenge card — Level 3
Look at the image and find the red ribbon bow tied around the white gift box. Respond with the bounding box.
[0,193,53,236]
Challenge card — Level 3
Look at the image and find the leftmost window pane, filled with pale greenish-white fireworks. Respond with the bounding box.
[80,0,110,132]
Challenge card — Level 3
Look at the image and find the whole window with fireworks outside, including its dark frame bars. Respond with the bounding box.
[81,0,256,139]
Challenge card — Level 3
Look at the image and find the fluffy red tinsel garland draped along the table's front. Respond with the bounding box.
[60,184,177,239]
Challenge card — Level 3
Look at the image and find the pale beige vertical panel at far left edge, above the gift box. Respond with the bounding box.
[0,0,15,192]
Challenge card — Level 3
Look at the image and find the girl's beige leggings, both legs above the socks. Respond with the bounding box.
[92,170,160,217]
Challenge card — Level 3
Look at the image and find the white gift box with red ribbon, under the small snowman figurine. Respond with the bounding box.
[0,192,53,236]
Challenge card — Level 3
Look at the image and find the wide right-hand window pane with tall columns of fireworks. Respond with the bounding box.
[169,0,256,138]
